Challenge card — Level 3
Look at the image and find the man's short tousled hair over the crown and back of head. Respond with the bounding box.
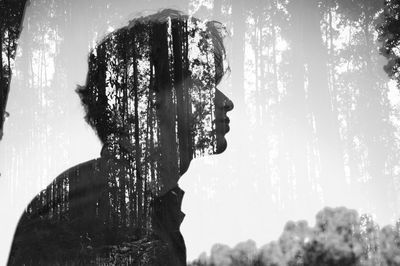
[76,9,228,143]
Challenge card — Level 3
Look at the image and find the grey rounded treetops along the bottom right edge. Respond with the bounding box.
[189,207,400,266]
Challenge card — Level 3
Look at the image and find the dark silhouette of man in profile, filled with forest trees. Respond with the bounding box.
[8,10,233,266]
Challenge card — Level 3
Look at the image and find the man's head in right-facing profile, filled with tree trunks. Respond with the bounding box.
[77,10,233,193]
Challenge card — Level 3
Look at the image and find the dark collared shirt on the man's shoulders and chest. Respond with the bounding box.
[8,158,186,266]
